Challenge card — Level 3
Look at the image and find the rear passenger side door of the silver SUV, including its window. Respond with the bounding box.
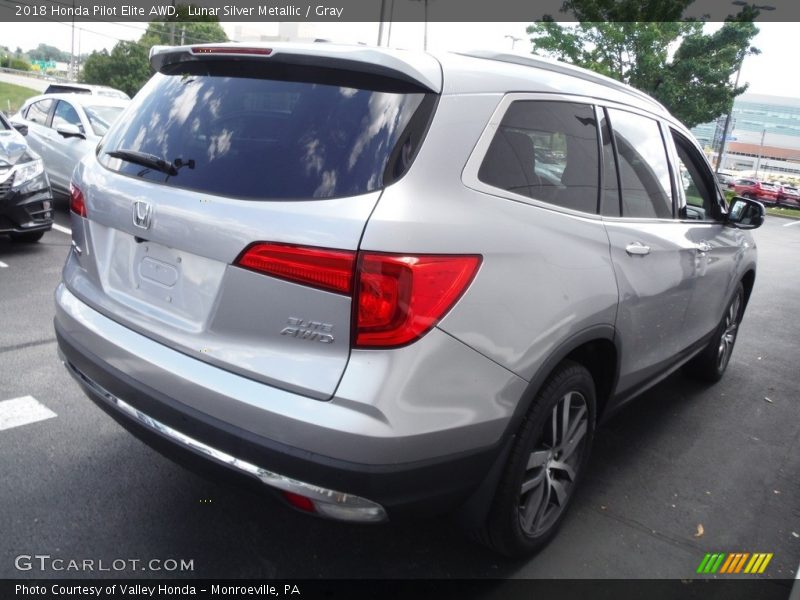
[602,108,695,393]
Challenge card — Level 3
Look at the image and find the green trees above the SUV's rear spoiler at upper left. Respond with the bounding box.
[81,5,228,96]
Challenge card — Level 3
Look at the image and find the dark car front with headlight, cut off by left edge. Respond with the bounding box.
[0,113,53,242]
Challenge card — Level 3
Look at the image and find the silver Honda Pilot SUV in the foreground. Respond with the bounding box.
[55,44,764,555]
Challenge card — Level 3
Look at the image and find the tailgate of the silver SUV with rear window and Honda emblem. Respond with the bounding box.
[65,50,435,399]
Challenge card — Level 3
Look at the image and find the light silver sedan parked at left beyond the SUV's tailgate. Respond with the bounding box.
[12,94,130,195]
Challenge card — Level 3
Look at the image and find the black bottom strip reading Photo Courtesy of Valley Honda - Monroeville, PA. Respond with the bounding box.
[0,578,792,600]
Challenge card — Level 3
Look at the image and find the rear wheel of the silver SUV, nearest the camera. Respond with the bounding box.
[477,361,596,557]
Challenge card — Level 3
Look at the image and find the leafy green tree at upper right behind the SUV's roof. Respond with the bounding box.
[528,0,758,127]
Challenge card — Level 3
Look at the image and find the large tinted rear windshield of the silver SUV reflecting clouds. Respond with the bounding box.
[98,61,436,200]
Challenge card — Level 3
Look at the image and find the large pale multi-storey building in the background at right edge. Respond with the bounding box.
[692,94,800,180]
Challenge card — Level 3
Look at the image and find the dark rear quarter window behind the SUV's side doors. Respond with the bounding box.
[478,100,599,213]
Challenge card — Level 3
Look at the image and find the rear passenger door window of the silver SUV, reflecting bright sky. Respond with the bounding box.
[608,109,672,219]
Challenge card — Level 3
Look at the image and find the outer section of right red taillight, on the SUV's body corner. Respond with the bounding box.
[354,253,481,348]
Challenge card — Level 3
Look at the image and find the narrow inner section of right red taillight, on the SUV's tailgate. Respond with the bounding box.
[236,243,356,294]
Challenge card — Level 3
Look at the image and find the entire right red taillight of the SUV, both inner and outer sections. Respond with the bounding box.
[234,243,481,348]
